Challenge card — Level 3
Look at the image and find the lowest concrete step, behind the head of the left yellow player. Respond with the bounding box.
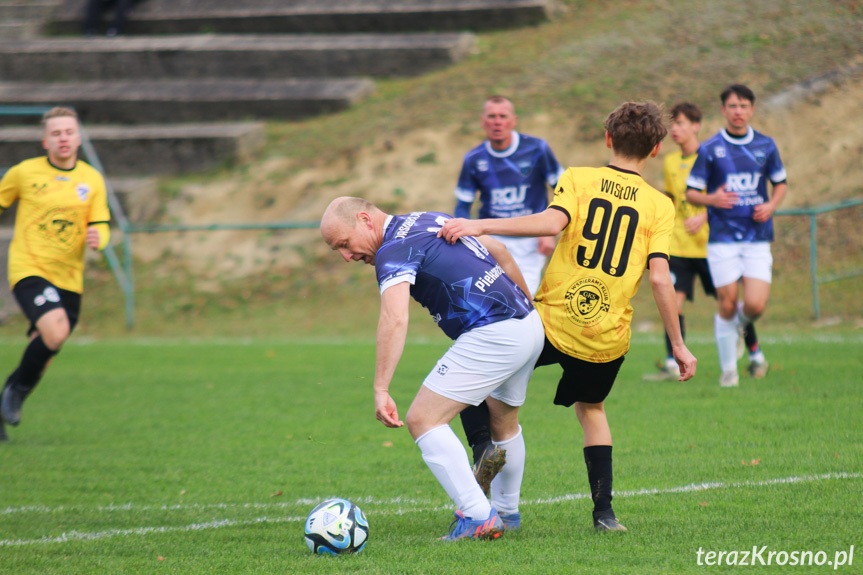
[0,122,266,176]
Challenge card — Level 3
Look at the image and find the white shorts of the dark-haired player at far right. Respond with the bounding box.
[707,242,773,287]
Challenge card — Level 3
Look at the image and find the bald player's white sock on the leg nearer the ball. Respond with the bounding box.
[416,425,491,519]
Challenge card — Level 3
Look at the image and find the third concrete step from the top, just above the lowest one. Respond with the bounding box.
[0,78,374,124]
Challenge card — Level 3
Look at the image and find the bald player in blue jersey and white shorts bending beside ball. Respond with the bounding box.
[321,197,545,540]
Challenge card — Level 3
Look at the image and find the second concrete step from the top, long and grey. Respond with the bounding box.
[0,33,476,81]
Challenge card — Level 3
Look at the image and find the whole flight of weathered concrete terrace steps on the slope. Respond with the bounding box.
[0,0,553,189]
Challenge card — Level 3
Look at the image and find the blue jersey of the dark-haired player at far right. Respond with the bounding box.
[686,127,786,243]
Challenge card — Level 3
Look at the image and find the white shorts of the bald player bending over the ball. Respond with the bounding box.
[423,310,545,406]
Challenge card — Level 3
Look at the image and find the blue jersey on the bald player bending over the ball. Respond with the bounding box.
[375,212,533,339]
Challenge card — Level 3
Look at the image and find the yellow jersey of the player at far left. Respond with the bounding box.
[0,157,110,293]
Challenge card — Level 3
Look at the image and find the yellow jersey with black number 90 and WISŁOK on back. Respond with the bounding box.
[535,167,674,363]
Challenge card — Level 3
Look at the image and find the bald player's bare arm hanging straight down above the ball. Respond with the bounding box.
[375,282,410,427]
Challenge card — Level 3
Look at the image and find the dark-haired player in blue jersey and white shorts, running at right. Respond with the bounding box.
[686,84,788,387]
